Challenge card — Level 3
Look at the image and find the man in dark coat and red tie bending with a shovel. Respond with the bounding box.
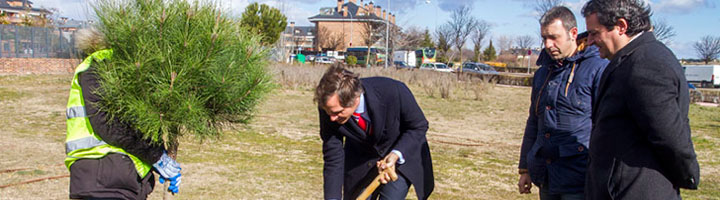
[315,65,434,199]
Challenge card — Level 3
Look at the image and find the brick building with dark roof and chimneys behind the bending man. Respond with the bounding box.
[308,0,395,51]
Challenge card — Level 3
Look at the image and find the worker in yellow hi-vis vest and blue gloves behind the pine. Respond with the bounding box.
[65,29,180,199]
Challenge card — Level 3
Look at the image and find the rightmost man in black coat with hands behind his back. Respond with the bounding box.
[582,0,700,199]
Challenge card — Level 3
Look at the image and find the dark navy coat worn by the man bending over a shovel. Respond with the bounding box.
[319,77,434,199]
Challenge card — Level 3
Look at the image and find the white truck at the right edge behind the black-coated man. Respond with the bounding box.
[683,65,720,88]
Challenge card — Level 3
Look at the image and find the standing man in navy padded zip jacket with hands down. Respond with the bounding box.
[518,6,608,200]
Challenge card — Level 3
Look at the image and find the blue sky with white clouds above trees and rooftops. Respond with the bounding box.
[33,0,720,58]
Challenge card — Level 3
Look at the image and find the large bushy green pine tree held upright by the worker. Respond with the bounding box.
[94,0,273,152]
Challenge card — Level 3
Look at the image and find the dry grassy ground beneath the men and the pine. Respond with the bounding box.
[0,68,720,199]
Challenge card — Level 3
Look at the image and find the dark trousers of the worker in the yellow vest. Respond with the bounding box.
[70,153,155,199]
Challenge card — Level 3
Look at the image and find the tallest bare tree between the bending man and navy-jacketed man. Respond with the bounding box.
[448,5,477,66]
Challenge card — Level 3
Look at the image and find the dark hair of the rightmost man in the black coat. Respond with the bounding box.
[582,0,652,36]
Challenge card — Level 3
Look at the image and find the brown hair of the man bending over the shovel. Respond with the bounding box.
[313,64,363,107]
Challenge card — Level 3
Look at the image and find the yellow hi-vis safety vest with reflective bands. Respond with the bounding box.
[65,50,152,177]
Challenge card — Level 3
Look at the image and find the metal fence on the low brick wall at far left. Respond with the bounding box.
[0,25,77,58]
